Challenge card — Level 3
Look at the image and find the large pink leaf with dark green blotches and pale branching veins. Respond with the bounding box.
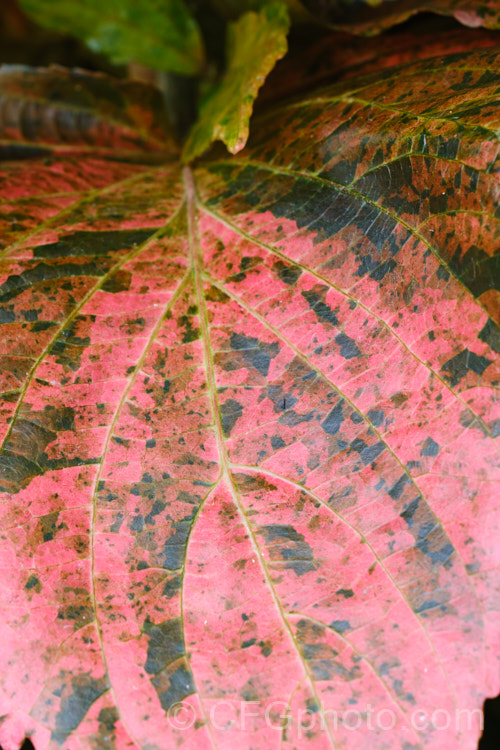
[0,50,500,750]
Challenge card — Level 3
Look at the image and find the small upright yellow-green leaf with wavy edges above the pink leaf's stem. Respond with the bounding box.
[184,2,290,161]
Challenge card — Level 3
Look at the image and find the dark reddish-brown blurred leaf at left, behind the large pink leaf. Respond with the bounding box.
[0,65,177,159]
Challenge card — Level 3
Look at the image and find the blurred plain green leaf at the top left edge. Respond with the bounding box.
[21,0,204,75]
